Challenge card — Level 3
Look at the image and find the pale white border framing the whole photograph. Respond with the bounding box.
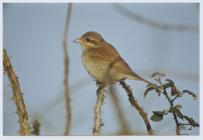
[0,0,203,140]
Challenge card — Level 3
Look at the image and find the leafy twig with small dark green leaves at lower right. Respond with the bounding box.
[145,73,199,135]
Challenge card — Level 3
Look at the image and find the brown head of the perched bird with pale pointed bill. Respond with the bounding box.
[74,32,104,50]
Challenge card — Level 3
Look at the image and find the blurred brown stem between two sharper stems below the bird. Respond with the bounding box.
[109,84,131,135]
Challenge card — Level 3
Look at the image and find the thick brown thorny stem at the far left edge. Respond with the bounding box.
[3,49,30,135]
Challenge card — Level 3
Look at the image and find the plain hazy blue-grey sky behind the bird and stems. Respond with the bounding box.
[3,3,199,135]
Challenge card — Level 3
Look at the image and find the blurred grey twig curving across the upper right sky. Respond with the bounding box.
[112,4,199,32]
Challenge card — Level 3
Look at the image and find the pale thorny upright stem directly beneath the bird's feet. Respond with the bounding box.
[92,85,105,136]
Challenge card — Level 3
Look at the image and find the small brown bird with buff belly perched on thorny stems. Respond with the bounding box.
[74,31,152,85]
